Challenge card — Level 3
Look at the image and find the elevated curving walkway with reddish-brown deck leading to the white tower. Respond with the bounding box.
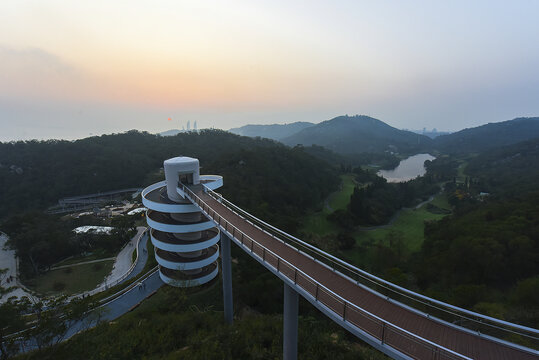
[182,185,539,360]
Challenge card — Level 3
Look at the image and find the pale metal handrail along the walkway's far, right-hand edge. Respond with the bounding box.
[204,186,539,339]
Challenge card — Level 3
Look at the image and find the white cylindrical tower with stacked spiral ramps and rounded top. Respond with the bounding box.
[142,156,223,287]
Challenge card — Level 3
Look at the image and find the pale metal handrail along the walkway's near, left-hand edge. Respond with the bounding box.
[183,185,471,360]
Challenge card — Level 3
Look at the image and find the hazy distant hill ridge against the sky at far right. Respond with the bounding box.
[434,117,539,153]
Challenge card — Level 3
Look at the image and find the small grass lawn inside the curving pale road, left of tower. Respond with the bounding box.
[25,260,114,295]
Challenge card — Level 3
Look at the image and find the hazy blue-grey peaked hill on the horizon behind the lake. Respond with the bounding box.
[281,115,432,154]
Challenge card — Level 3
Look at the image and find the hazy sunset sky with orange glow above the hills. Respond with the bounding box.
[0,0,539,141]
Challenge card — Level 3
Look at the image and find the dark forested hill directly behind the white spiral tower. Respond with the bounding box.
[0,130,339,228]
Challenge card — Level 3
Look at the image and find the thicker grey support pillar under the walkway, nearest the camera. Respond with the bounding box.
[283,283,299,360]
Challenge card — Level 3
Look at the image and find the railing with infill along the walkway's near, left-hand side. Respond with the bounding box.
[183,186,470,360]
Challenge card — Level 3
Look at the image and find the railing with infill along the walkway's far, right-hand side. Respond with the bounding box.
[199,188,539,347]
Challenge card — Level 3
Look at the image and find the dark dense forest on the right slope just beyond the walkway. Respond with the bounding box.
[414,139,539,326]
